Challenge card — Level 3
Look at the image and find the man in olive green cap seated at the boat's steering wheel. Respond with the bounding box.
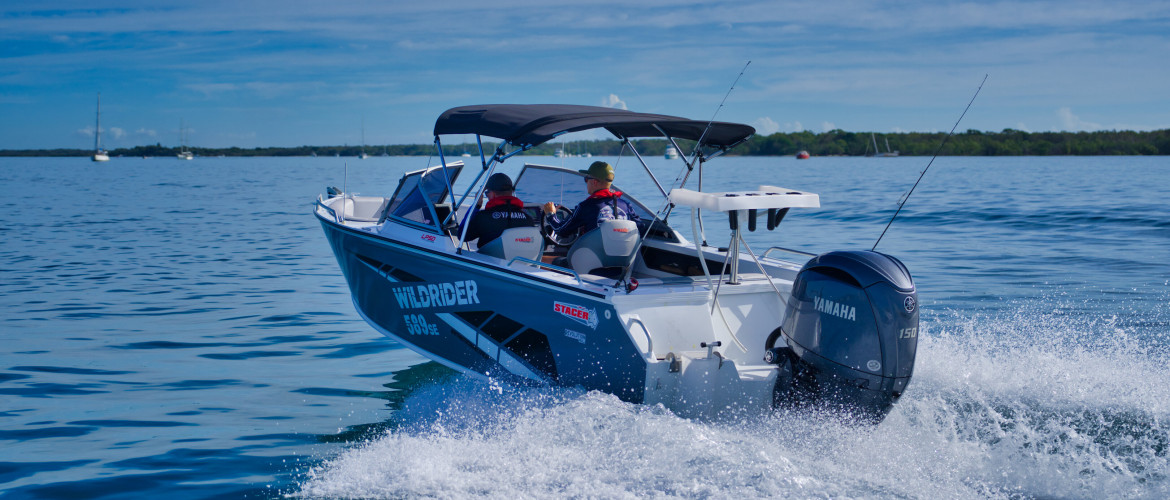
[544,162,638,234]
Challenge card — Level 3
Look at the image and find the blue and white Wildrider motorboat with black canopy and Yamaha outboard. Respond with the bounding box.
[314,104,918,423]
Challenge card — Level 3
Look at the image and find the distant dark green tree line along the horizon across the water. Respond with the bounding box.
[0,129,1170,157]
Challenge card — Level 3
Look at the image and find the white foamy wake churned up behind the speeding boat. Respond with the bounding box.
[291,302,1170,498]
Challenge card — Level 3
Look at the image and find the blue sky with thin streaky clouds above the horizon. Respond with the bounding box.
[0,0,1170,149]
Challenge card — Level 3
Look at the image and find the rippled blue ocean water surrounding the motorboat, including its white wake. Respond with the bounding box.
[0,157,1170,499]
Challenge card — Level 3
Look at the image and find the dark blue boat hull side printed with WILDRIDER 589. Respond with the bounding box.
[318,217,647,403]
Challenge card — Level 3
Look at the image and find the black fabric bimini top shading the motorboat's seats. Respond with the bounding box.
[435,104,756,148]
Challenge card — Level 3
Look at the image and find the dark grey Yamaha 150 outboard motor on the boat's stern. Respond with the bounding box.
[764,251,918,424]
